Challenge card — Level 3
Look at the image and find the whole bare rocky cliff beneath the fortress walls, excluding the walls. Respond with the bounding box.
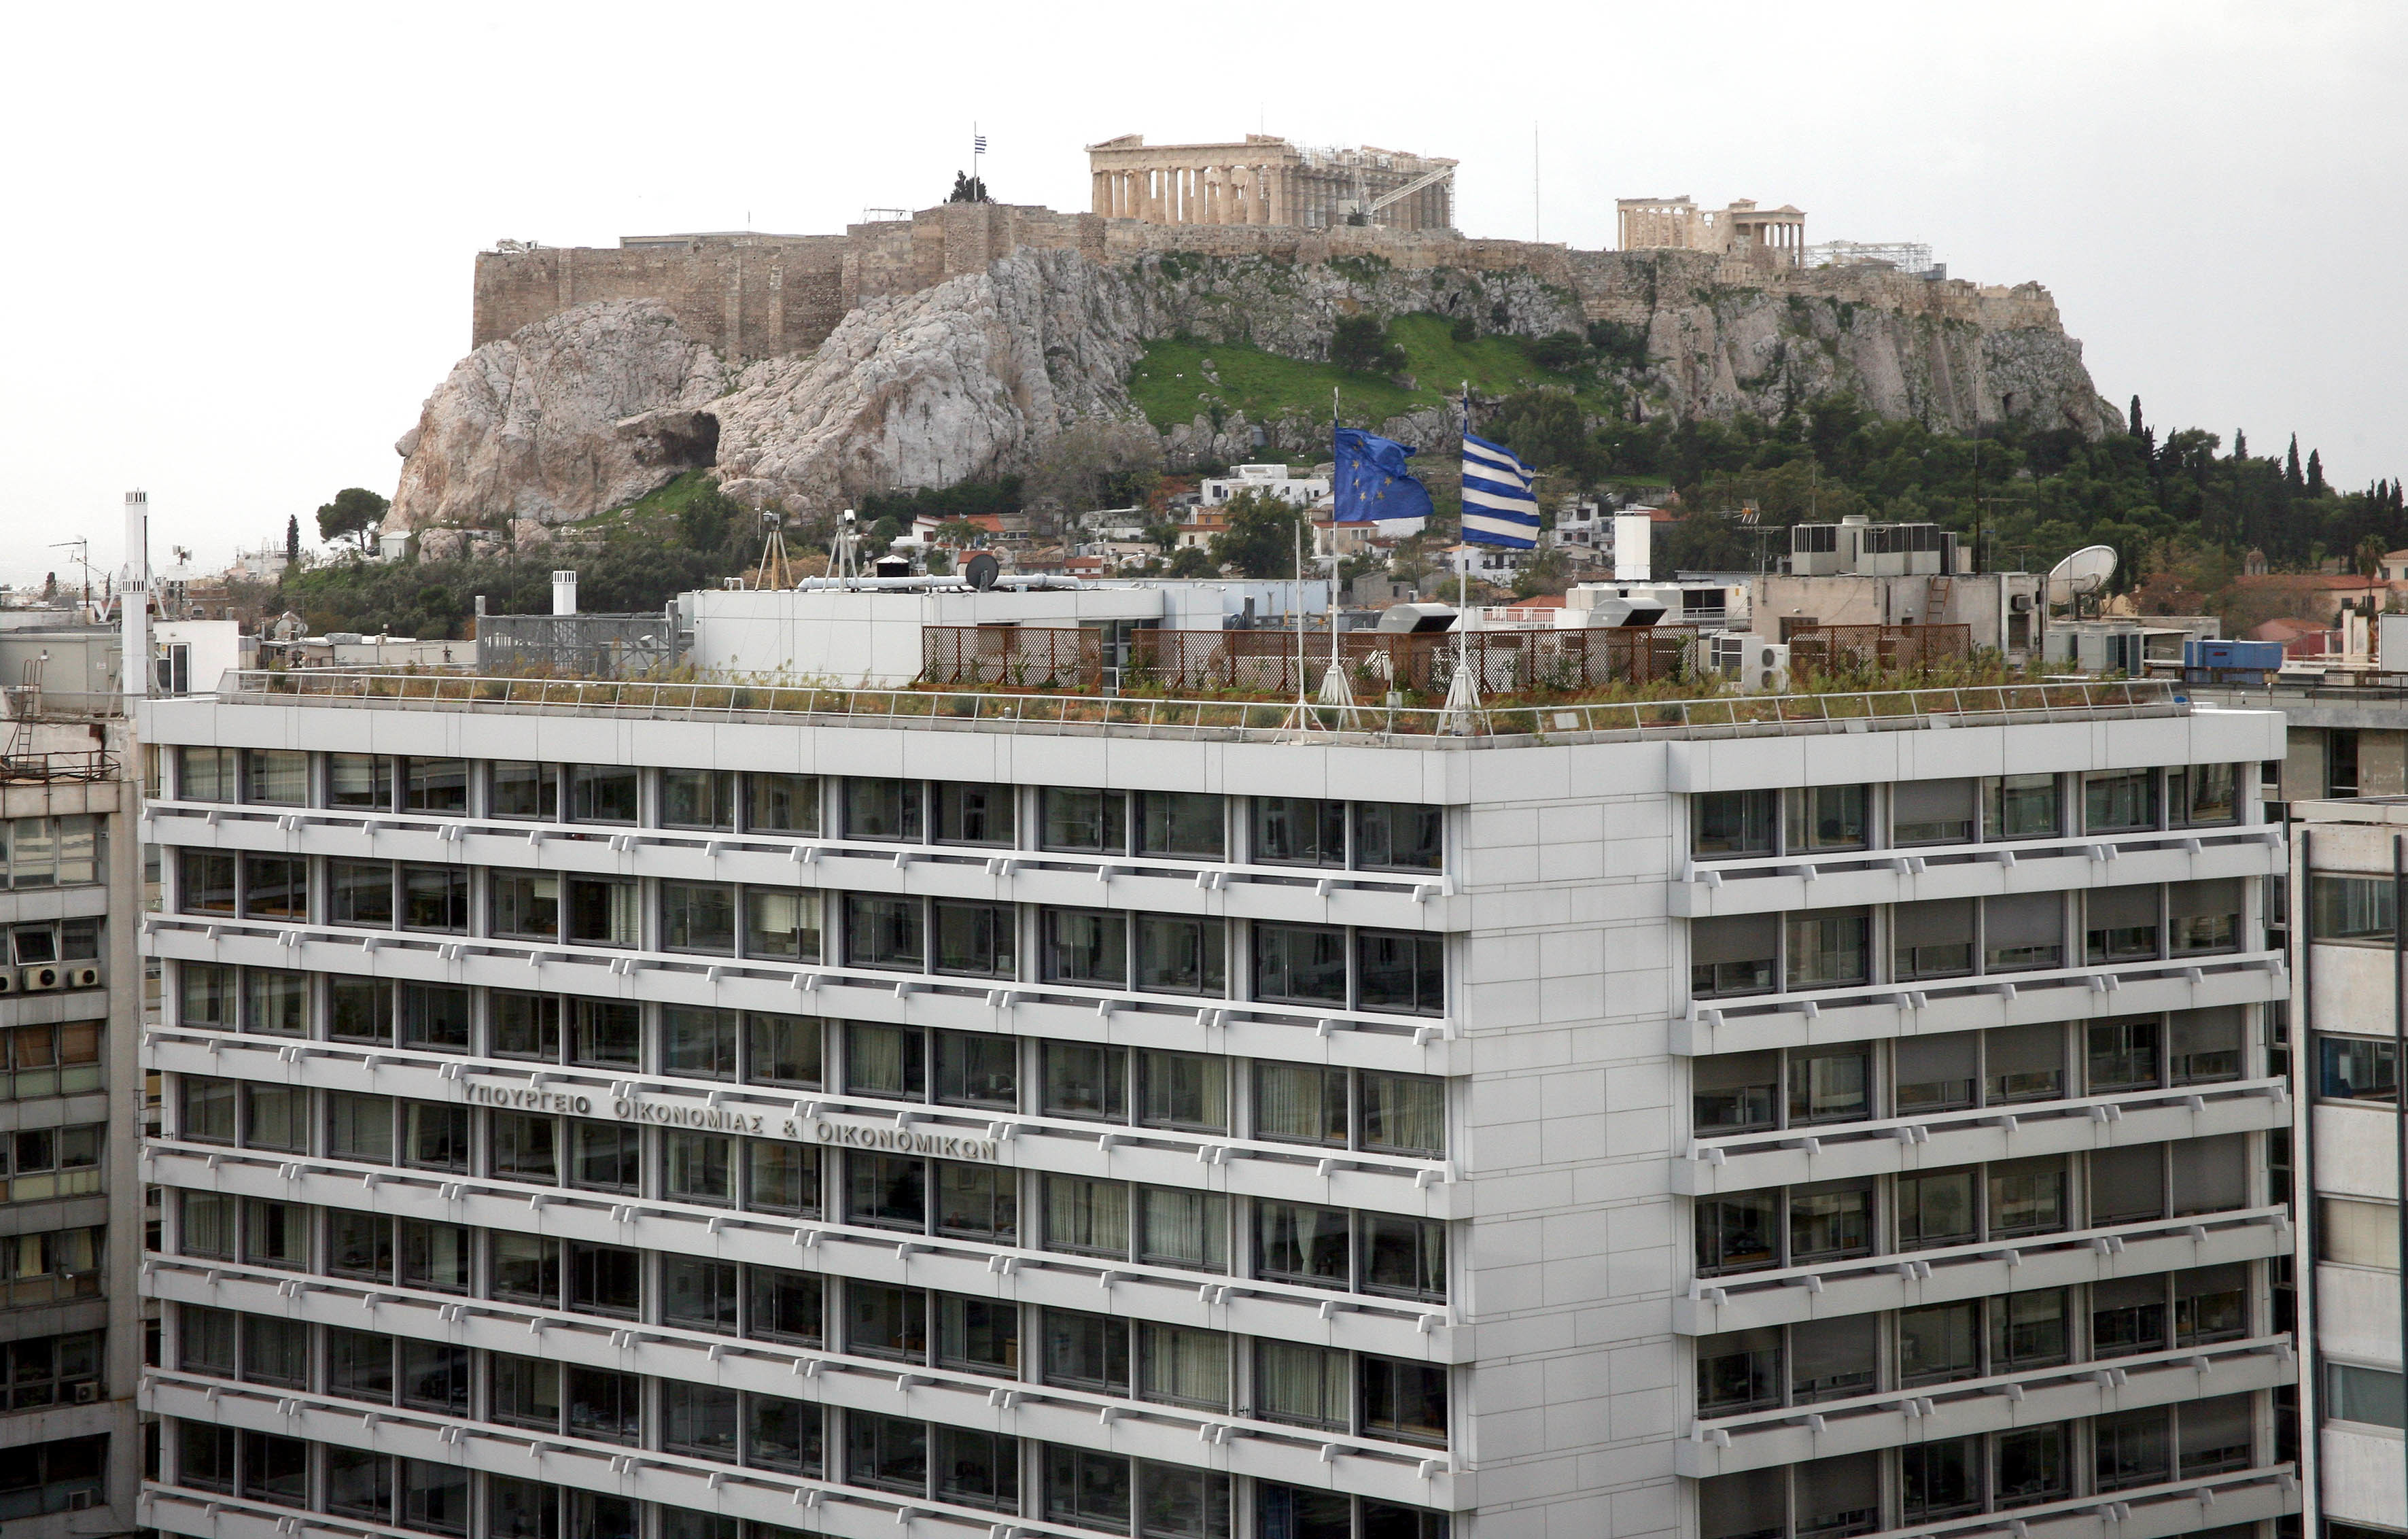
[385,248,2119,535]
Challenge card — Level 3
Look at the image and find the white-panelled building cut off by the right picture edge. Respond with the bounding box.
[2290,795,2408,1539]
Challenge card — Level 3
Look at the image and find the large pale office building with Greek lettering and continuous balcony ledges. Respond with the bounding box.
[145,621,2297,1539]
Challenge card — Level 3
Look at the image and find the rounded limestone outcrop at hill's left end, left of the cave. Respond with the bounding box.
[385,298,727,530]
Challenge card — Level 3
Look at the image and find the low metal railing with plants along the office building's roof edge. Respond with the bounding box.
[217,670,2189,746]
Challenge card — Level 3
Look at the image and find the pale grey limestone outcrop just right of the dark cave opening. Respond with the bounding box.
[713,250,1149,513]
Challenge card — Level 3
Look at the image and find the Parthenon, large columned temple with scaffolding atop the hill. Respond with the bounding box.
[1086,133,1454,229]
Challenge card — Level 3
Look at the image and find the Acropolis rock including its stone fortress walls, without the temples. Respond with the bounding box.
[387,192,2121,549]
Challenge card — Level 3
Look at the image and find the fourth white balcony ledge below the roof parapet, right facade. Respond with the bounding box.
[1671,1207,2292,1336]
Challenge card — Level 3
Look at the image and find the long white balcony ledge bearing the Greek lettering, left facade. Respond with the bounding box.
[145,1026,1469,1219]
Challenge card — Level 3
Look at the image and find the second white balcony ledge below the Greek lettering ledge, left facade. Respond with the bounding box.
[142,1255,1447,1500]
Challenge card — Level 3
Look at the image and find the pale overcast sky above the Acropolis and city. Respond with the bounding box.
[0,0,2408,583]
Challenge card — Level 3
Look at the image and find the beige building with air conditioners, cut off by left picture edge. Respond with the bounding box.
[0,679,145,1539]
